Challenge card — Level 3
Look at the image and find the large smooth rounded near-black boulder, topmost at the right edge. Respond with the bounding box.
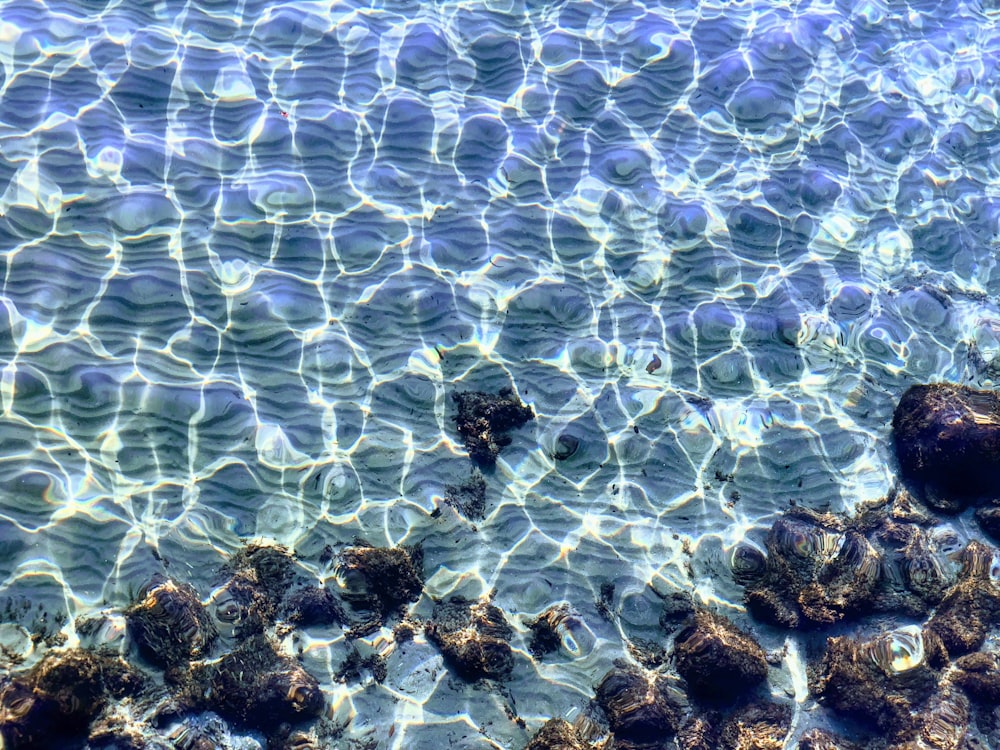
[892,383,1000,513]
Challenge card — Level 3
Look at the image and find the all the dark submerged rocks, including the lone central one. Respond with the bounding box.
[11,385,1000,750]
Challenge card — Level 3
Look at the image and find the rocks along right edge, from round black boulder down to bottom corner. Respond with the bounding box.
[733,384,1000,749]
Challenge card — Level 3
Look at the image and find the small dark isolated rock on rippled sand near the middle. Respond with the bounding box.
[452,387,535,466]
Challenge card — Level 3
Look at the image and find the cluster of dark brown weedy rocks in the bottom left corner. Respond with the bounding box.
[0,544,423,750]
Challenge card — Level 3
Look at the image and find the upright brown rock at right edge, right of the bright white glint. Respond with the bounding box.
[928,541,1000,657]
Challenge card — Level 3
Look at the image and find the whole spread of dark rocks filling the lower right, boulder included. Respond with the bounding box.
[529,384,1000,750]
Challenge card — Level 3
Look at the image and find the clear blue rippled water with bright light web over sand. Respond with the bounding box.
[0,1,1000,747]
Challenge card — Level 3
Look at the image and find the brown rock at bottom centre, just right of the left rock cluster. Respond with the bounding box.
[424,597,514,680]
